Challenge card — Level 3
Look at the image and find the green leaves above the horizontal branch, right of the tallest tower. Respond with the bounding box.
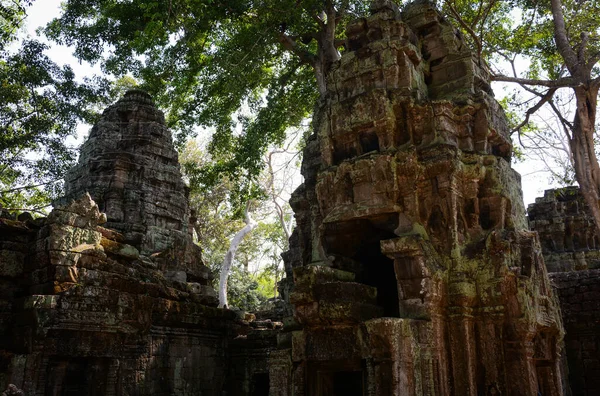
[443,0,600,80]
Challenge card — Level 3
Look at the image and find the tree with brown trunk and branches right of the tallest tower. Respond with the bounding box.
[444,0,600,232]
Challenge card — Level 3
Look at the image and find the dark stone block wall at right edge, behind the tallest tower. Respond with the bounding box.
[528,187,600,395]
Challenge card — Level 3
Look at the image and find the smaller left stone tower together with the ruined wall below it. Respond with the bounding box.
[0,91,276,396]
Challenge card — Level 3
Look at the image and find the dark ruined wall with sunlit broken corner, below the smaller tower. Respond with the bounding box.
[0,195,237,395]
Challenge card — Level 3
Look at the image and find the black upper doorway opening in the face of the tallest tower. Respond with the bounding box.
[324,214,400,317]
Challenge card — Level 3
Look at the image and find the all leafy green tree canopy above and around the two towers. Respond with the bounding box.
[0,0,600,304]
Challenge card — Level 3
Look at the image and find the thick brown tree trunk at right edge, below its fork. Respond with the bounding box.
[569,86,600,235]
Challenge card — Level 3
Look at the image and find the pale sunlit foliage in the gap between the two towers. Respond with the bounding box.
[179,140,287,311]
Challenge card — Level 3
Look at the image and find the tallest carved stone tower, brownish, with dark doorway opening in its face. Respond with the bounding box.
[270,1,563,396]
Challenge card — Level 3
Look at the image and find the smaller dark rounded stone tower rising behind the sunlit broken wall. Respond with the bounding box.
[61,90,205,281]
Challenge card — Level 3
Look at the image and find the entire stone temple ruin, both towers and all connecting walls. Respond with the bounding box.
[0,1,600,396]
